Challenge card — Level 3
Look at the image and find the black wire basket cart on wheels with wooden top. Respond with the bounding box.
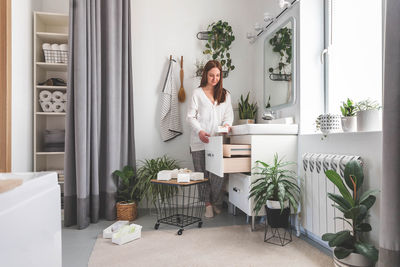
[151,179,208,235]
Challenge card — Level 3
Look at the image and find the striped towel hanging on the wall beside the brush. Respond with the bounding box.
[160,60,183,142]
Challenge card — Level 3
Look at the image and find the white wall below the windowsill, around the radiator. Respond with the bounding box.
[298,132,382,245]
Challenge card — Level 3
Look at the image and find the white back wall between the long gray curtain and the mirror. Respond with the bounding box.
[132,0,276,167]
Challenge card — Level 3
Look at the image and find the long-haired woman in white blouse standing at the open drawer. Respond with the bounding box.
[187,60,233,218]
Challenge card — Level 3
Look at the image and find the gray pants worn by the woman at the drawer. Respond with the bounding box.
[190,150,224,203]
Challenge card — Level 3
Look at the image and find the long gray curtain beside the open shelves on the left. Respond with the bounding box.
[64,0,135,229]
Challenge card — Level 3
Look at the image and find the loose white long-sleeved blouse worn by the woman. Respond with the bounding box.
[186,88,233,151]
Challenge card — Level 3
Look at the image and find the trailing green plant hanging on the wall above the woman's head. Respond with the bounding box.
[203,20,235,78]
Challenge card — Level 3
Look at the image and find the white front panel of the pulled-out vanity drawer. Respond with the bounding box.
[205,136,224,177]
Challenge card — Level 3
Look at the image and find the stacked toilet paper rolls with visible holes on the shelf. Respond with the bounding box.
[39,90,67,112]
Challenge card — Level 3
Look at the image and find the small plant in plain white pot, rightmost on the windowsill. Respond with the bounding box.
[356,99,382,132]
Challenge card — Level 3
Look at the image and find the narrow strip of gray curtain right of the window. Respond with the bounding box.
[379,0,400,267]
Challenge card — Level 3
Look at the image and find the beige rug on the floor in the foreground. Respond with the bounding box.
[89,225,333,267]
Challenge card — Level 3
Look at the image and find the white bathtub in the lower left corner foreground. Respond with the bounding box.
[0,172,61,267]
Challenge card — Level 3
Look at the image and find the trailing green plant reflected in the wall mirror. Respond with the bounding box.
[269,27,292,74]
